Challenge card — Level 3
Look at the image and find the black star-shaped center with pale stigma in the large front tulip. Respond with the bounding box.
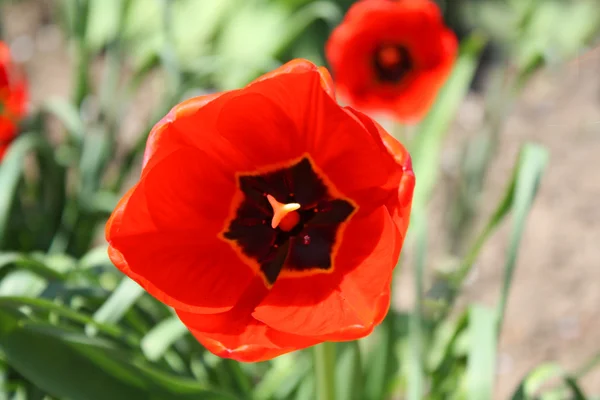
[223,157,356,284]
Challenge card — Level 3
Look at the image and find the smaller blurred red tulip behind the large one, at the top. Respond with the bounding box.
[326,0,457,122]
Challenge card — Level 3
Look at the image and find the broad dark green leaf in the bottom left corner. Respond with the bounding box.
[0,308,237,400]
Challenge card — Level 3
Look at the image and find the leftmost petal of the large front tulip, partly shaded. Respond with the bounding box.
[107,148,255,313]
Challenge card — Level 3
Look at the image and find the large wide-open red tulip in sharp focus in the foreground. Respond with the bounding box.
[106,60,414,361]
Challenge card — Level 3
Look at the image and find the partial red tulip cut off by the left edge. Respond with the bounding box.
[0,42,27,160]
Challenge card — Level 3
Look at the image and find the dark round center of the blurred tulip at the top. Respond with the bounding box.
[373,44,413,83]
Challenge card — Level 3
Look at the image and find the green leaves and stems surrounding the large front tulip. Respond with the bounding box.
[0,0,600,400]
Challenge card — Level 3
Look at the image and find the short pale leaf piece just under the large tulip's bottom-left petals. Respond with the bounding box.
[140,315,189,361]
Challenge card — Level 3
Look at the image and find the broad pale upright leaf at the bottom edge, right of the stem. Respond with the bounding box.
[467,305,497,400]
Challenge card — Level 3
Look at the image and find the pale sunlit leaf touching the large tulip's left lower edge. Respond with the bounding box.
[85,277,144,335]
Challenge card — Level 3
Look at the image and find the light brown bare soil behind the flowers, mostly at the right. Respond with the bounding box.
[2,1,600,399]
